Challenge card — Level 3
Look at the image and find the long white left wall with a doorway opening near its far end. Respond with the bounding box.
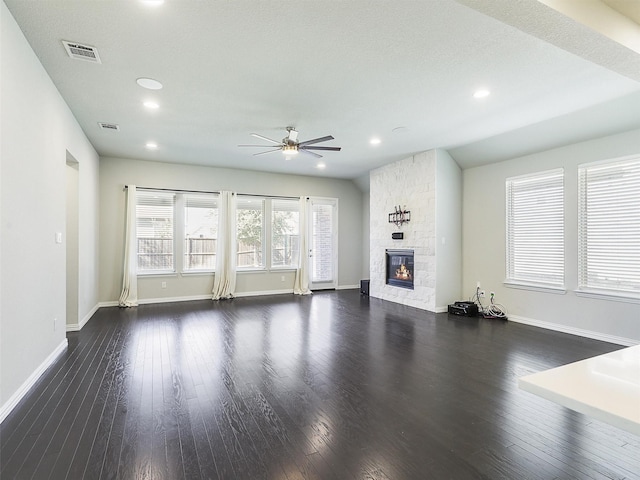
[0,2,98,412]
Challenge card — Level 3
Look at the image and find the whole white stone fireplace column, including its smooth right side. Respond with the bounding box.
[365,150,462,312]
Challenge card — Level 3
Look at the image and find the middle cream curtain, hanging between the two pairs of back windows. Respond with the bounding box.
[211,191,236,300]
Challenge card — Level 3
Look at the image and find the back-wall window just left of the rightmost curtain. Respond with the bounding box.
[271,199,300,268]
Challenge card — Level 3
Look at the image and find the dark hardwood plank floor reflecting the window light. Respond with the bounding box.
[0,290,640,480]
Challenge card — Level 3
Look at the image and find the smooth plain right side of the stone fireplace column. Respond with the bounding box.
[435,150,462,312]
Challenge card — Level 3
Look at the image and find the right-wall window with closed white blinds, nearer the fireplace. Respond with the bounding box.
[506,169,564,288]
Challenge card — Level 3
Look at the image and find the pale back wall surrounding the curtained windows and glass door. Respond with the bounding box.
[100,158,362,302]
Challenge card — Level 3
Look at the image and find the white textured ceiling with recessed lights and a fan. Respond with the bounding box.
[4,0,640,178]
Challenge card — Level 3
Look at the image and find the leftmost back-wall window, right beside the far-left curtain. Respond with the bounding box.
[136,190,175,273]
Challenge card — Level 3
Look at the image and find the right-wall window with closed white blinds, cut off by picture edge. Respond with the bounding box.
[578,156,640,297]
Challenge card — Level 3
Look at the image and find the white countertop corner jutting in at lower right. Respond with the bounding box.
[518,345,640,436]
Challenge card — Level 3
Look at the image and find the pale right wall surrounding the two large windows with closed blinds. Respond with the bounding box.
[463,130,640,344]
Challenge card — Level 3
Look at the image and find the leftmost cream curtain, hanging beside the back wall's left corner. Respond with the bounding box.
[118,185,138,307]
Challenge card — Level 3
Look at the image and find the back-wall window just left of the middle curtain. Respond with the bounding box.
[182,194,218,272]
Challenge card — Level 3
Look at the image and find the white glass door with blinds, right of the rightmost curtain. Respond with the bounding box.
[307,197,338,290]
